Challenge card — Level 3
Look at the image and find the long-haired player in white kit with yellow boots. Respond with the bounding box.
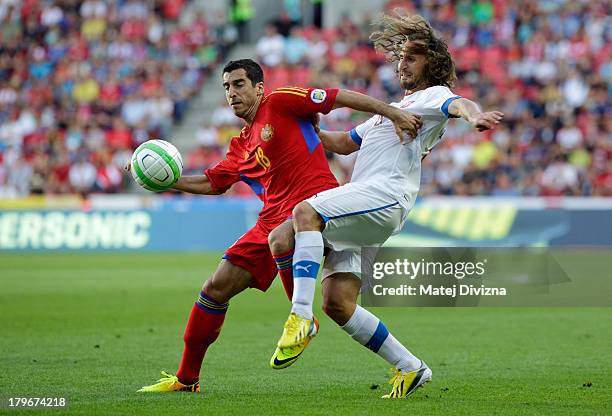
[270,16,503,398]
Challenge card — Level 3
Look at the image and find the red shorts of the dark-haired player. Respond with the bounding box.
[223,221,278,292]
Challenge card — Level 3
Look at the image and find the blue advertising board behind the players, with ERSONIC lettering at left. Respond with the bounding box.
[0,197,612,251]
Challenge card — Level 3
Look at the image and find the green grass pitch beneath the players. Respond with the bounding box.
[0,254,612,415]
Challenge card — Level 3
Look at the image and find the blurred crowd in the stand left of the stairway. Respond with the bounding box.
[0,0,235,198]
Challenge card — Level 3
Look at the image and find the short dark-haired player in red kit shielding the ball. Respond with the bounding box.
[139,59,420,392]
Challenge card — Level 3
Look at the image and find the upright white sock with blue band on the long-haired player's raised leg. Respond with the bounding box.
[291,231,323,319]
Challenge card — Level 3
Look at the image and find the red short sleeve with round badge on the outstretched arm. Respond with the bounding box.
[268,87,338,118]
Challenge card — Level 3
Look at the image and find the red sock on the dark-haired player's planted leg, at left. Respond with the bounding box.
[176,292,227,384]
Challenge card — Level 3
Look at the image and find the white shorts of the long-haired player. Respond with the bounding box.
[306,182,408,278]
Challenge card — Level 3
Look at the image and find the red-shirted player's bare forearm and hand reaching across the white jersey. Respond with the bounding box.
[334,90,423,142]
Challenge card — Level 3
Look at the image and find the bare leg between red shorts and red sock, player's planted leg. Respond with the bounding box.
[202,259,253,303]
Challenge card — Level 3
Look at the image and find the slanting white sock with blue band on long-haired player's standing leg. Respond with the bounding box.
[342,305,421,372]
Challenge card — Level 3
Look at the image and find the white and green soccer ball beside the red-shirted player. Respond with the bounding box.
[130,140,183,192]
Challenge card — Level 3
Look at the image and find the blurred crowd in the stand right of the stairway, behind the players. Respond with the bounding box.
[188,0,612,196]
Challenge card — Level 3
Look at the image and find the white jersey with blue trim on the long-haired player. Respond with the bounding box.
[350,86,461,210]
